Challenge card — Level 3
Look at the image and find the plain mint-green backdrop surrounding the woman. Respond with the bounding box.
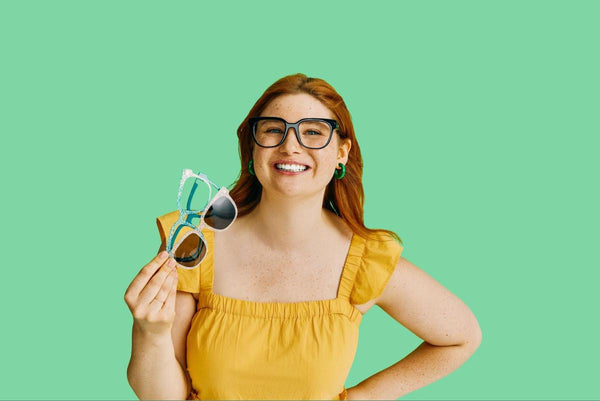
[0,1,600,399]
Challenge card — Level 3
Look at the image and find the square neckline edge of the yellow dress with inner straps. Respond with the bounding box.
[200,228,362,306]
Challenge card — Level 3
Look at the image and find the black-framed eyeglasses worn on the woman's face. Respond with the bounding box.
[249,117,340,149]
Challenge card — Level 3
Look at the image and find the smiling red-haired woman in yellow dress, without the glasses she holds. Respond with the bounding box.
[125,74,481,399]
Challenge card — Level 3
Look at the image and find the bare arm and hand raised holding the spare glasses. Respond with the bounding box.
[125,248,196,400]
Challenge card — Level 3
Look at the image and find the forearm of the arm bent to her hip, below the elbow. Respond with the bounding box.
[348,341,477,400]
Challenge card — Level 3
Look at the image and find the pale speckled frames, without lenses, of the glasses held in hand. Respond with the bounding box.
[166,168,238,269]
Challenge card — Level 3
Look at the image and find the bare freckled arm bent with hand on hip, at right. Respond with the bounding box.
[348,257,481,400]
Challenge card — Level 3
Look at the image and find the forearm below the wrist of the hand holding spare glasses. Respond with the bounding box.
[127,323,190,400]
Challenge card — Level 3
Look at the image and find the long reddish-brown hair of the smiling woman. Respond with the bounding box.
[230,73,403,244]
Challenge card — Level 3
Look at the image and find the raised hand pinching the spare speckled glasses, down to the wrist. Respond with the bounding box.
[125,251,177,335]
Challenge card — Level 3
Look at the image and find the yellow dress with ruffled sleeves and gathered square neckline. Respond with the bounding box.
[157,211,402,400]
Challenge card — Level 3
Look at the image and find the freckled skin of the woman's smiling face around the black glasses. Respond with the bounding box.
[252,93,351,200]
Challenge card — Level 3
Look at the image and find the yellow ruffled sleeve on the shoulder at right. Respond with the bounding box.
[350,233,403,305]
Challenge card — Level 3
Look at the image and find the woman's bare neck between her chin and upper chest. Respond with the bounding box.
[248,189,331,251]
